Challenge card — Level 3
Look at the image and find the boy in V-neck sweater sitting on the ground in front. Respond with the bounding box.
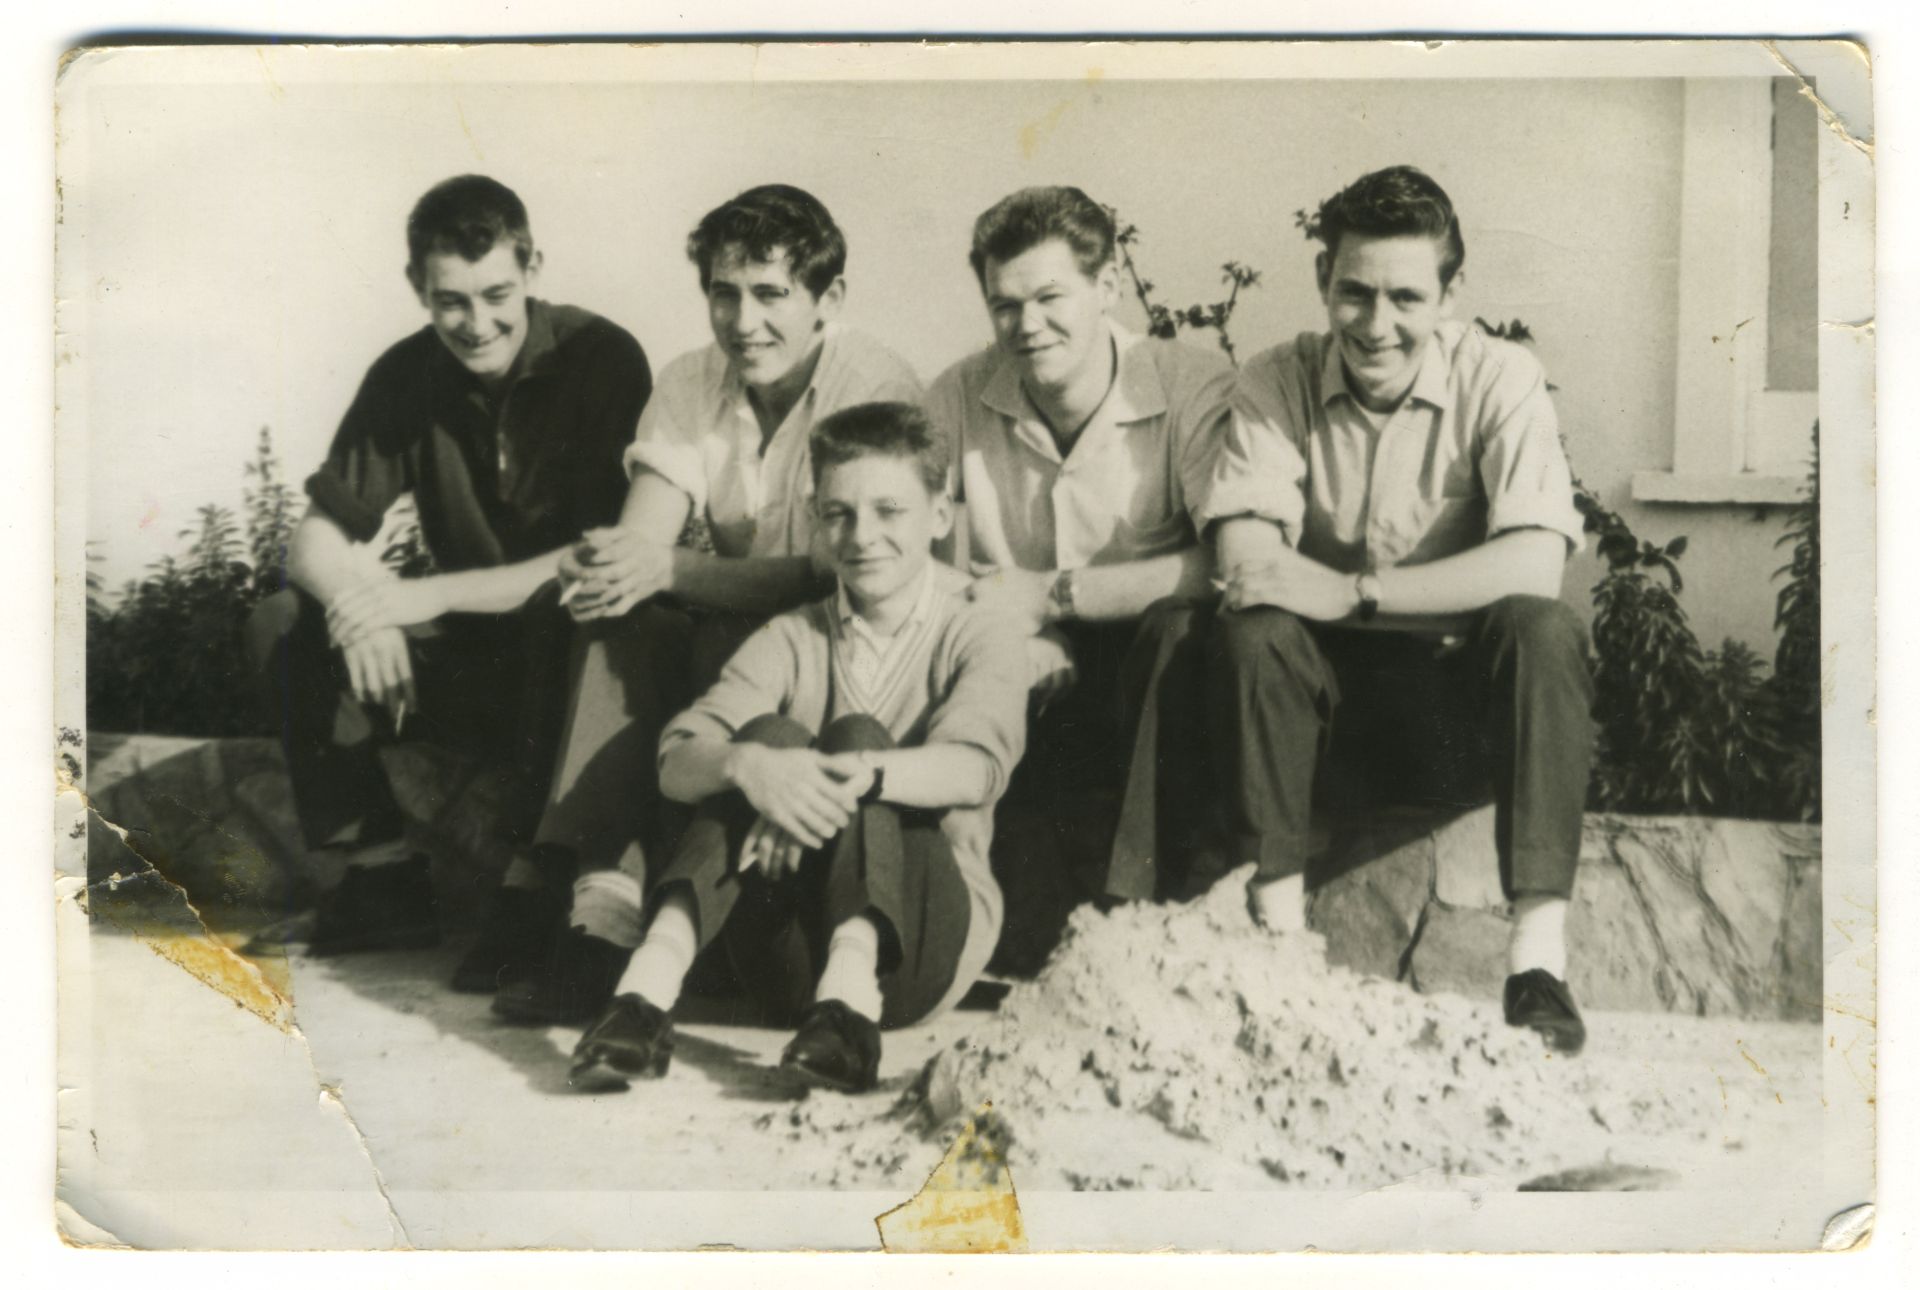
[572,403,1027,1090]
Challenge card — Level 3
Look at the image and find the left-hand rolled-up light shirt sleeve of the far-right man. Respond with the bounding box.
[1194,347,1308,545]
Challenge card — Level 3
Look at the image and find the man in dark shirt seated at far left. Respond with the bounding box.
[250,175,651,954]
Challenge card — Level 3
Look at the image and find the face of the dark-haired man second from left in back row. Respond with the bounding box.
[707,246,847,388]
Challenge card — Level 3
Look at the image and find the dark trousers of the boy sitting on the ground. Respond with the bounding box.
[649,716,972,1027]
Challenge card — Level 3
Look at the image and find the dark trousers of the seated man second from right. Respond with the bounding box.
[1000,601,1213,898]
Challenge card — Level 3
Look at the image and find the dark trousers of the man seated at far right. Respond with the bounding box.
[1208,595,1594,898]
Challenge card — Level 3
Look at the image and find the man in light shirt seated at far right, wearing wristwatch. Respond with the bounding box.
[1202,167,1592,1052]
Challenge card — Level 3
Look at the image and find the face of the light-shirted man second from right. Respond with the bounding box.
[981,238,1119,390]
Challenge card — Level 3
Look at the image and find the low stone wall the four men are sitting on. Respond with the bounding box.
[88,735,1820,1019]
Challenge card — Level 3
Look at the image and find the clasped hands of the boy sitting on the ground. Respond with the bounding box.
[728,743,877,877]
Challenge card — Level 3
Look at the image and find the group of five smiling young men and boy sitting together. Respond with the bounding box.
[253,167,1590,1090]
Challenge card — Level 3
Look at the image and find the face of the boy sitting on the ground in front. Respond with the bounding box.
[814,453,954,614]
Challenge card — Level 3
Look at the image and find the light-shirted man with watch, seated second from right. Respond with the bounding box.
[927,188,1233,929]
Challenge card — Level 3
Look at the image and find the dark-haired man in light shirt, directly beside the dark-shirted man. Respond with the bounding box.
[457,184,920,1023]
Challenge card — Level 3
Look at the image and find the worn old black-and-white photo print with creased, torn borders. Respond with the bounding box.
[54,40,1878,1252]
